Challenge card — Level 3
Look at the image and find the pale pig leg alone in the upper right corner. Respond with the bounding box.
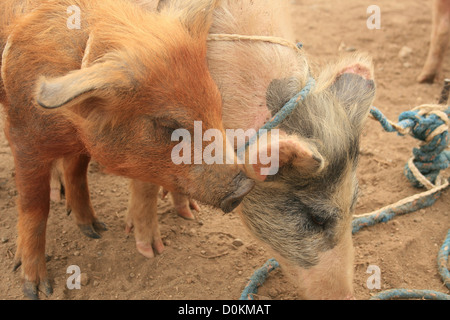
[417,0,450,83]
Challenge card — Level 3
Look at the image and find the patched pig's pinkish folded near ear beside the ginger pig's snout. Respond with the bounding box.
[248,134,325,181]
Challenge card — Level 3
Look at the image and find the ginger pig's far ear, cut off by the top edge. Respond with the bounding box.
[158,0,220,37]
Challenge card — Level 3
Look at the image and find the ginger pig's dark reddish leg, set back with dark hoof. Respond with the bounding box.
[64,154,107,239]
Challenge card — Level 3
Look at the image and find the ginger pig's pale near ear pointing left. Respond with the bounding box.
[35,61,130,109]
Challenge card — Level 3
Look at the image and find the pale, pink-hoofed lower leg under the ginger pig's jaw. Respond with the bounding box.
[126,180,164,258]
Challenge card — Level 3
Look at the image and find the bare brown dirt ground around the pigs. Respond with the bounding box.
[0,0,450,300]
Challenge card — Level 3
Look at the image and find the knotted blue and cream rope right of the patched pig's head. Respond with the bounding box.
[352,105,450,234]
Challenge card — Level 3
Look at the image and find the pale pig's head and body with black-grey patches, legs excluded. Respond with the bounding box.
[208,0,375,299]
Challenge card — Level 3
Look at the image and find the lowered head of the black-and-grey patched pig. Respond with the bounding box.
[239,59,375,299]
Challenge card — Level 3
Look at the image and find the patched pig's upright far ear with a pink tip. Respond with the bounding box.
[331,63,375,131]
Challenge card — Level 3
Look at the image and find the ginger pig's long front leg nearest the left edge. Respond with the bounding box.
[14,156,53,299]
